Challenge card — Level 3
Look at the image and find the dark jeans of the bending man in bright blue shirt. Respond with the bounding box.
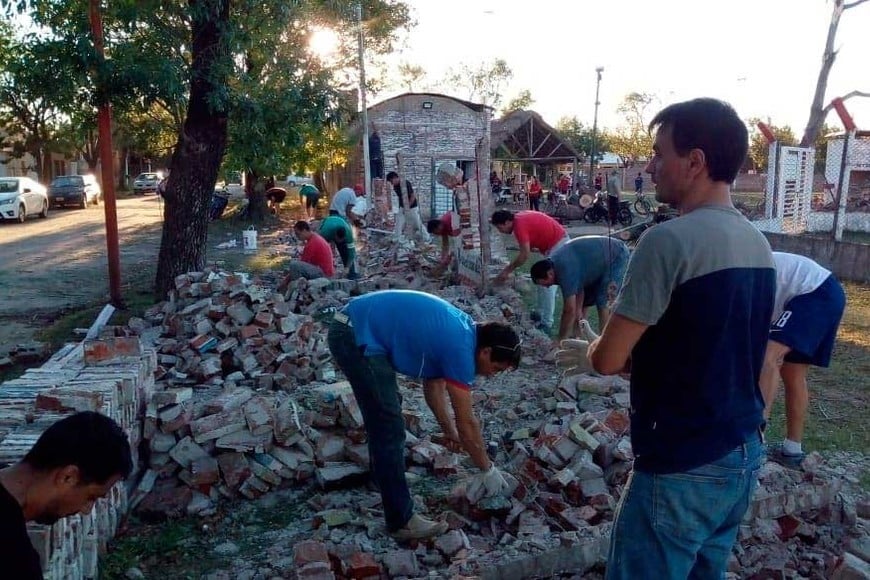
[327,320,414,532]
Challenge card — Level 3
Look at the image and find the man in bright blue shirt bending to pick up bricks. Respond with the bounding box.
[328,290,520,540]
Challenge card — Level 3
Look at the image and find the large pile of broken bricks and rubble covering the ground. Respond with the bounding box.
[119,264,867,578]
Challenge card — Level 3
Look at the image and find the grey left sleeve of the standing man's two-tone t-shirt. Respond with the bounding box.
[614,227,684,326]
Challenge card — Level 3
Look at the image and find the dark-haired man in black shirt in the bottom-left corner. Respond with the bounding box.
[0,412,133,580]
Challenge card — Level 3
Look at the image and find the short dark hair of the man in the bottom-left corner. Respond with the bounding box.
[24,411,133,484]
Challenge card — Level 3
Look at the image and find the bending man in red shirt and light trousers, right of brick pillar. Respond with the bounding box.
[491,209,570,332]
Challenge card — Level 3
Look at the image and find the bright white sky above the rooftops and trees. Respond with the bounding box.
[374,0,870,136]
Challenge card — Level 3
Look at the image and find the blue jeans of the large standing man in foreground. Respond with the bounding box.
[606,435,764,580]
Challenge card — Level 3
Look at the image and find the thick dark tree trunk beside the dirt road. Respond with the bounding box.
[154,0,230,300]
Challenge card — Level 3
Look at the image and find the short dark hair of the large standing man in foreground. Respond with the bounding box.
[649,98,749,183]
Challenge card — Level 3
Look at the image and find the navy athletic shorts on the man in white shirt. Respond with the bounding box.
[770,274,846,367]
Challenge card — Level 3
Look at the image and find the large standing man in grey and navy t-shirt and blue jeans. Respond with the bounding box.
[588,99,776,580]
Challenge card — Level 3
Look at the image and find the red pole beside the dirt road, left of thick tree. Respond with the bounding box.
[89,0,123,307]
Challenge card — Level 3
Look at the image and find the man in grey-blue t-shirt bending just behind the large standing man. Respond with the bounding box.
[531,236,629,340]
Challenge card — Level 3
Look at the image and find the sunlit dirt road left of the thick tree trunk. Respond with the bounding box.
[0,195,163,345]
